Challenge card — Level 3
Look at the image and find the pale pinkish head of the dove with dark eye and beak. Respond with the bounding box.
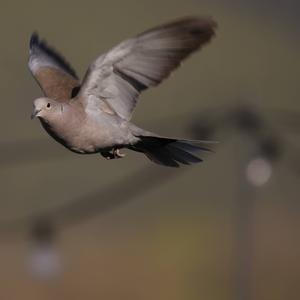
[31,98,63,120]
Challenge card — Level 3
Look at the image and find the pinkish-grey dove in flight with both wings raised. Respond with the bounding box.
[28,17,216,167]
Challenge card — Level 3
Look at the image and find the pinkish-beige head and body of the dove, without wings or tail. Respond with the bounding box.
[33,98,138,154]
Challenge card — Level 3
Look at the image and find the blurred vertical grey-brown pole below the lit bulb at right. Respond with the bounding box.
[234,134,256,300]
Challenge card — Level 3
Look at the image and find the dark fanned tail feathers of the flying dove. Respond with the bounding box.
[131,136,212,167]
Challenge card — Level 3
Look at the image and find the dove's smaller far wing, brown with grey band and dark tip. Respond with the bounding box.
[28,33,80,102]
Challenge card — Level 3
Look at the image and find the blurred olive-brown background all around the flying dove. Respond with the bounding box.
[0,0,300,300]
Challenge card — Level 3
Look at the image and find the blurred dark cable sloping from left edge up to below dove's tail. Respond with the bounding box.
[0,165,186,234]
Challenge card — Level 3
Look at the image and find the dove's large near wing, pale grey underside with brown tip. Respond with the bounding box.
[79,17,216,120]
